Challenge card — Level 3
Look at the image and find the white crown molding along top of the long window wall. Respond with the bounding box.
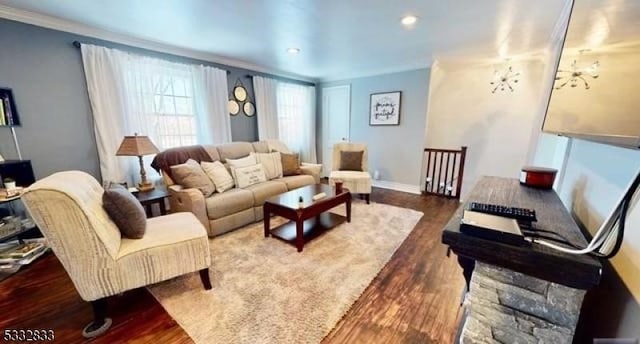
[0,4,317,83]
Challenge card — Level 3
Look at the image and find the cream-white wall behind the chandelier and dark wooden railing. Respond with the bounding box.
[425,59,546,198]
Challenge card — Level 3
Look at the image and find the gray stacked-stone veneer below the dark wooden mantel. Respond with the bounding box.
[461,262,585,344]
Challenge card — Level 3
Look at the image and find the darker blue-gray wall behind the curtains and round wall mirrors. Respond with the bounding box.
[0,19,310,178]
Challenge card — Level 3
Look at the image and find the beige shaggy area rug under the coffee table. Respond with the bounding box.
[149,202,422,344]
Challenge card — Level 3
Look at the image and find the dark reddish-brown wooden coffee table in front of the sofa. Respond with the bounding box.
[263,184,351,252]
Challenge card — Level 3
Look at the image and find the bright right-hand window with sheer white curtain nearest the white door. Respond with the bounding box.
[277,82,316,163]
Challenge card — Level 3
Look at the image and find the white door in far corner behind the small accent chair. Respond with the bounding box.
[322,85,351,177]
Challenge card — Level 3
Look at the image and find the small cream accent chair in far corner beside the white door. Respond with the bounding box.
[329,142,371,204]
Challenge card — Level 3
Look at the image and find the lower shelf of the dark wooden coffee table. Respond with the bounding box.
[270,212,347,250]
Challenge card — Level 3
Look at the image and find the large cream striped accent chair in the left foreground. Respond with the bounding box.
[22,171,211,337]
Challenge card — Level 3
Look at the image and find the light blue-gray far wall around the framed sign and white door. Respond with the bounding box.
[317,68,430,186]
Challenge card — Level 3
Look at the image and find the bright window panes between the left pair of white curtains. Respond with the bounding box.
[130,69,198,149]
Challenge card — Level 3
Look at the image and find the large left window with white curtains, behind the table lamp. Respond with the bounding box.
[81,44,231,185]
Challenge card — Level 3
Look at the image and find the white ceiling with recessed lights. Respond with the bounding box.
[0,0,569,80]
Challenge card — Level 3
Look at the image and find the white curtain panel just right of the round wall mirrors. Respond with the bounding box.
[253,76,278,140]
